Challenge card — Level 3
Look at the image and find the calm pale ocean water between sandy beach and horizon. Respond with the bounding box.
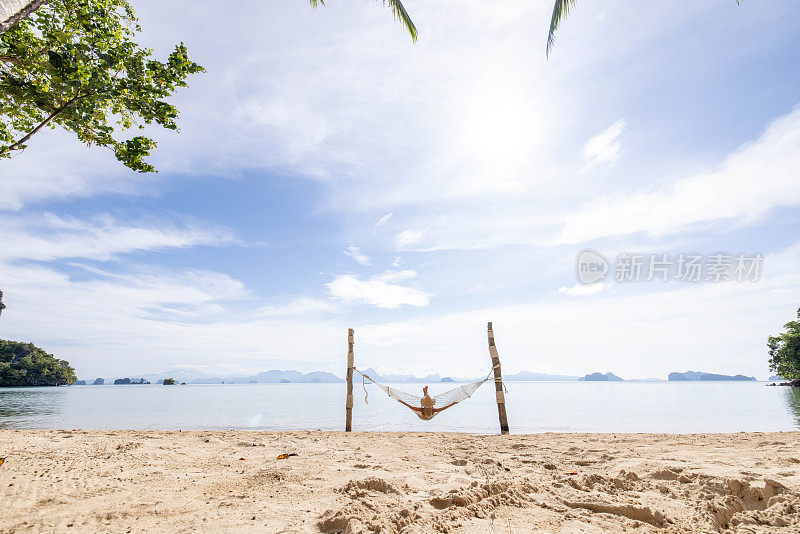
[0,382,800,434]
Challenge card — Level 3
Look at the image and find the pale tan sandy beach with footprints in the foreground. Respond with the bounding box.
[0,430,800,533]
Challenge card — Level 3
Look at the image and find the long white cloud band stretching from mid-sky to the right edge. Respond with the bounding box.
[366,108,800,255]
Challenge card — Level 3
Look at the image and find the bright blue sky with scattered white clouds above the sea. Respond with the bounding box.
[0,0,800,379]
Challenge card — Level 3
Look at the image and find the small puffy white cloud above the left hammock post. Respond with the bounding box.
[326,271,430,309]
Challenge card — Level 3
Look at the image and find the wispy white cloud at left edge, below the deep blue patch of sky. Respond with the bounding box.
[0,263,244,332]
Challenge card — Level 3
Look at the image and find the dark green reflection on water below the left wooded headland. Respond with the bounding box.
[0,388,67,428]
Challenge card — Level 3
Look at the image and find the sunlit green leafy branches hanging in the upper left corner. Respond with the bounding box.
[0,0,204,172]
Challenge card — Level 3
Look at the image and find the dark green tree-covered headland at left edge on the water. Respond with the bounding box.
[0,339,75,386]
